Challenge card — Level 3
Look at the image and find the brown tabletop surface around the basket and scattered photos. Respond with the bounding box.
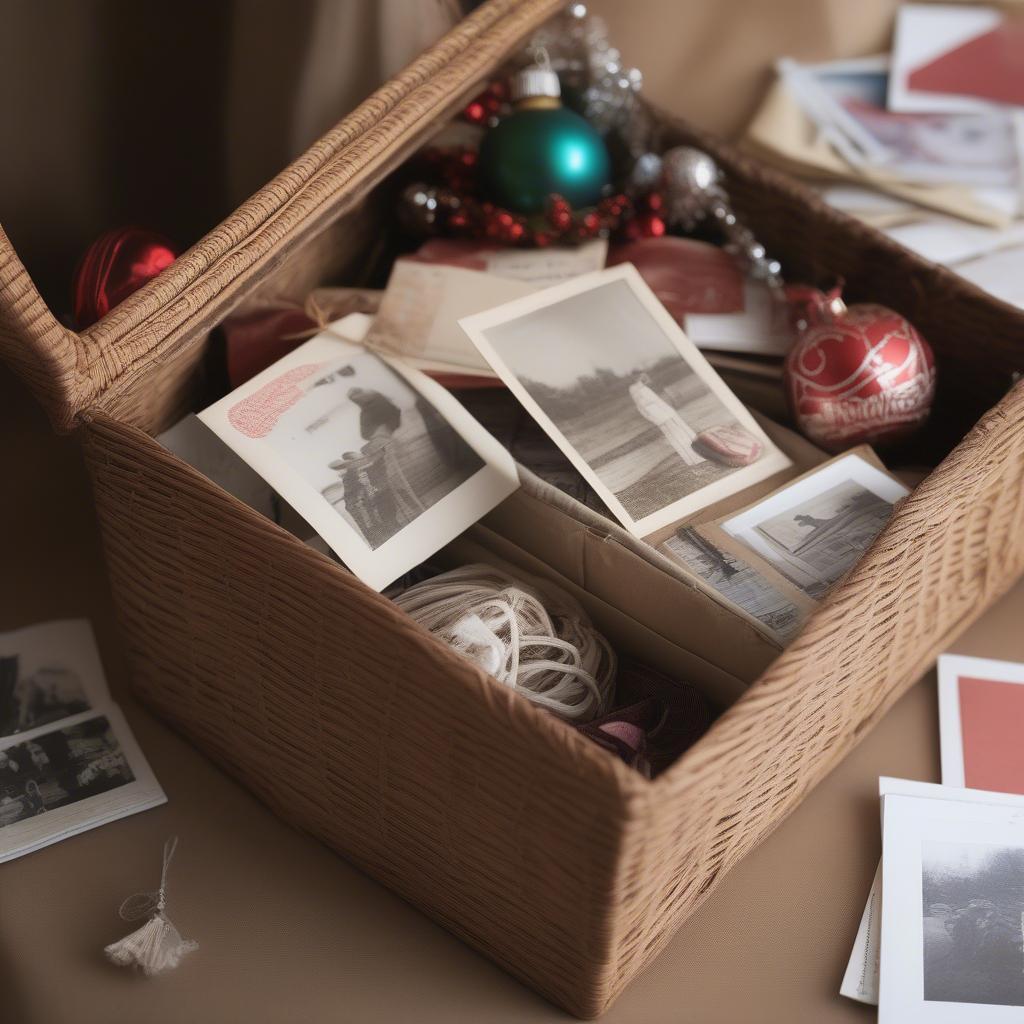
[0,362,1024,1024]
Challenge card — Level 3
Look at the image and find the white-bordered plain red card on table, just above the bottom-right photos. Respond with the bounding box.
[939,654,1024,794]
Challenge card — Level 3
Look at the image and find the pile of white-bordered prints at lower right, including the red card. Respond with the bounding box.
[840,655,1024,1024]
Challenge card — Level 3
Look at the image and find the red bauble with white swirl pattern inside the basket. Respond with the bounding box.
[785,288,935,452]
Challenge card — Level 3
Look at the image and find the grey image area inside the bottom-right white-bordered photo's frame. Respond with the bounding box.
[922,841,1024,1008]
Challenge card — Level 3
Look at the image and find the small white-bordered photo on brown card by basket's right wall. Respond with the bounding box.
[720,455,909,601]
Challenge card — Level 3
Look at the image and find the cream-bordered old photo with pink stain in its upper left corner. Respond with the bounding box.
[199,313,519,591]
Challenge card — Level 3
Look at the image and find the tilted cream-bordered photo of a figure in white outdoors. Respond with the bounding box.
[460,263,791,537]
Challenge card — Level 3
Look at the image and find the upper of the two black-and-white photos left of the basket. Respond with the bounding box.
[0,618,108,738]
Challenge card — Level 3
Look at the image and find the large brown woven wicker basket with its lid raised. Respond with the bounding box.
[0,0,1024,1016]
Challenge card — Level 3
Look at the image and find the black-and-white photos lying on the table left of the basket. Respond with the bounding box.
[0,620,167,863]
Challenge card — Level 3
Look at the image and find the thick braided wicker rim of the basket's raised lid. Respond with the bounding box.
[0,0,563,430]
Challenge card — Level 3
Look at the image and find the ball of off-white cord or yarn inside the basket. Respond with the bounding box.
[394,564,615,722]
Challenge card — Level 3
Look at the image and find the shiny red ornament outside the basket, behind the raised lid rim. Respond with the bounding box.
[72,227,177,328]
